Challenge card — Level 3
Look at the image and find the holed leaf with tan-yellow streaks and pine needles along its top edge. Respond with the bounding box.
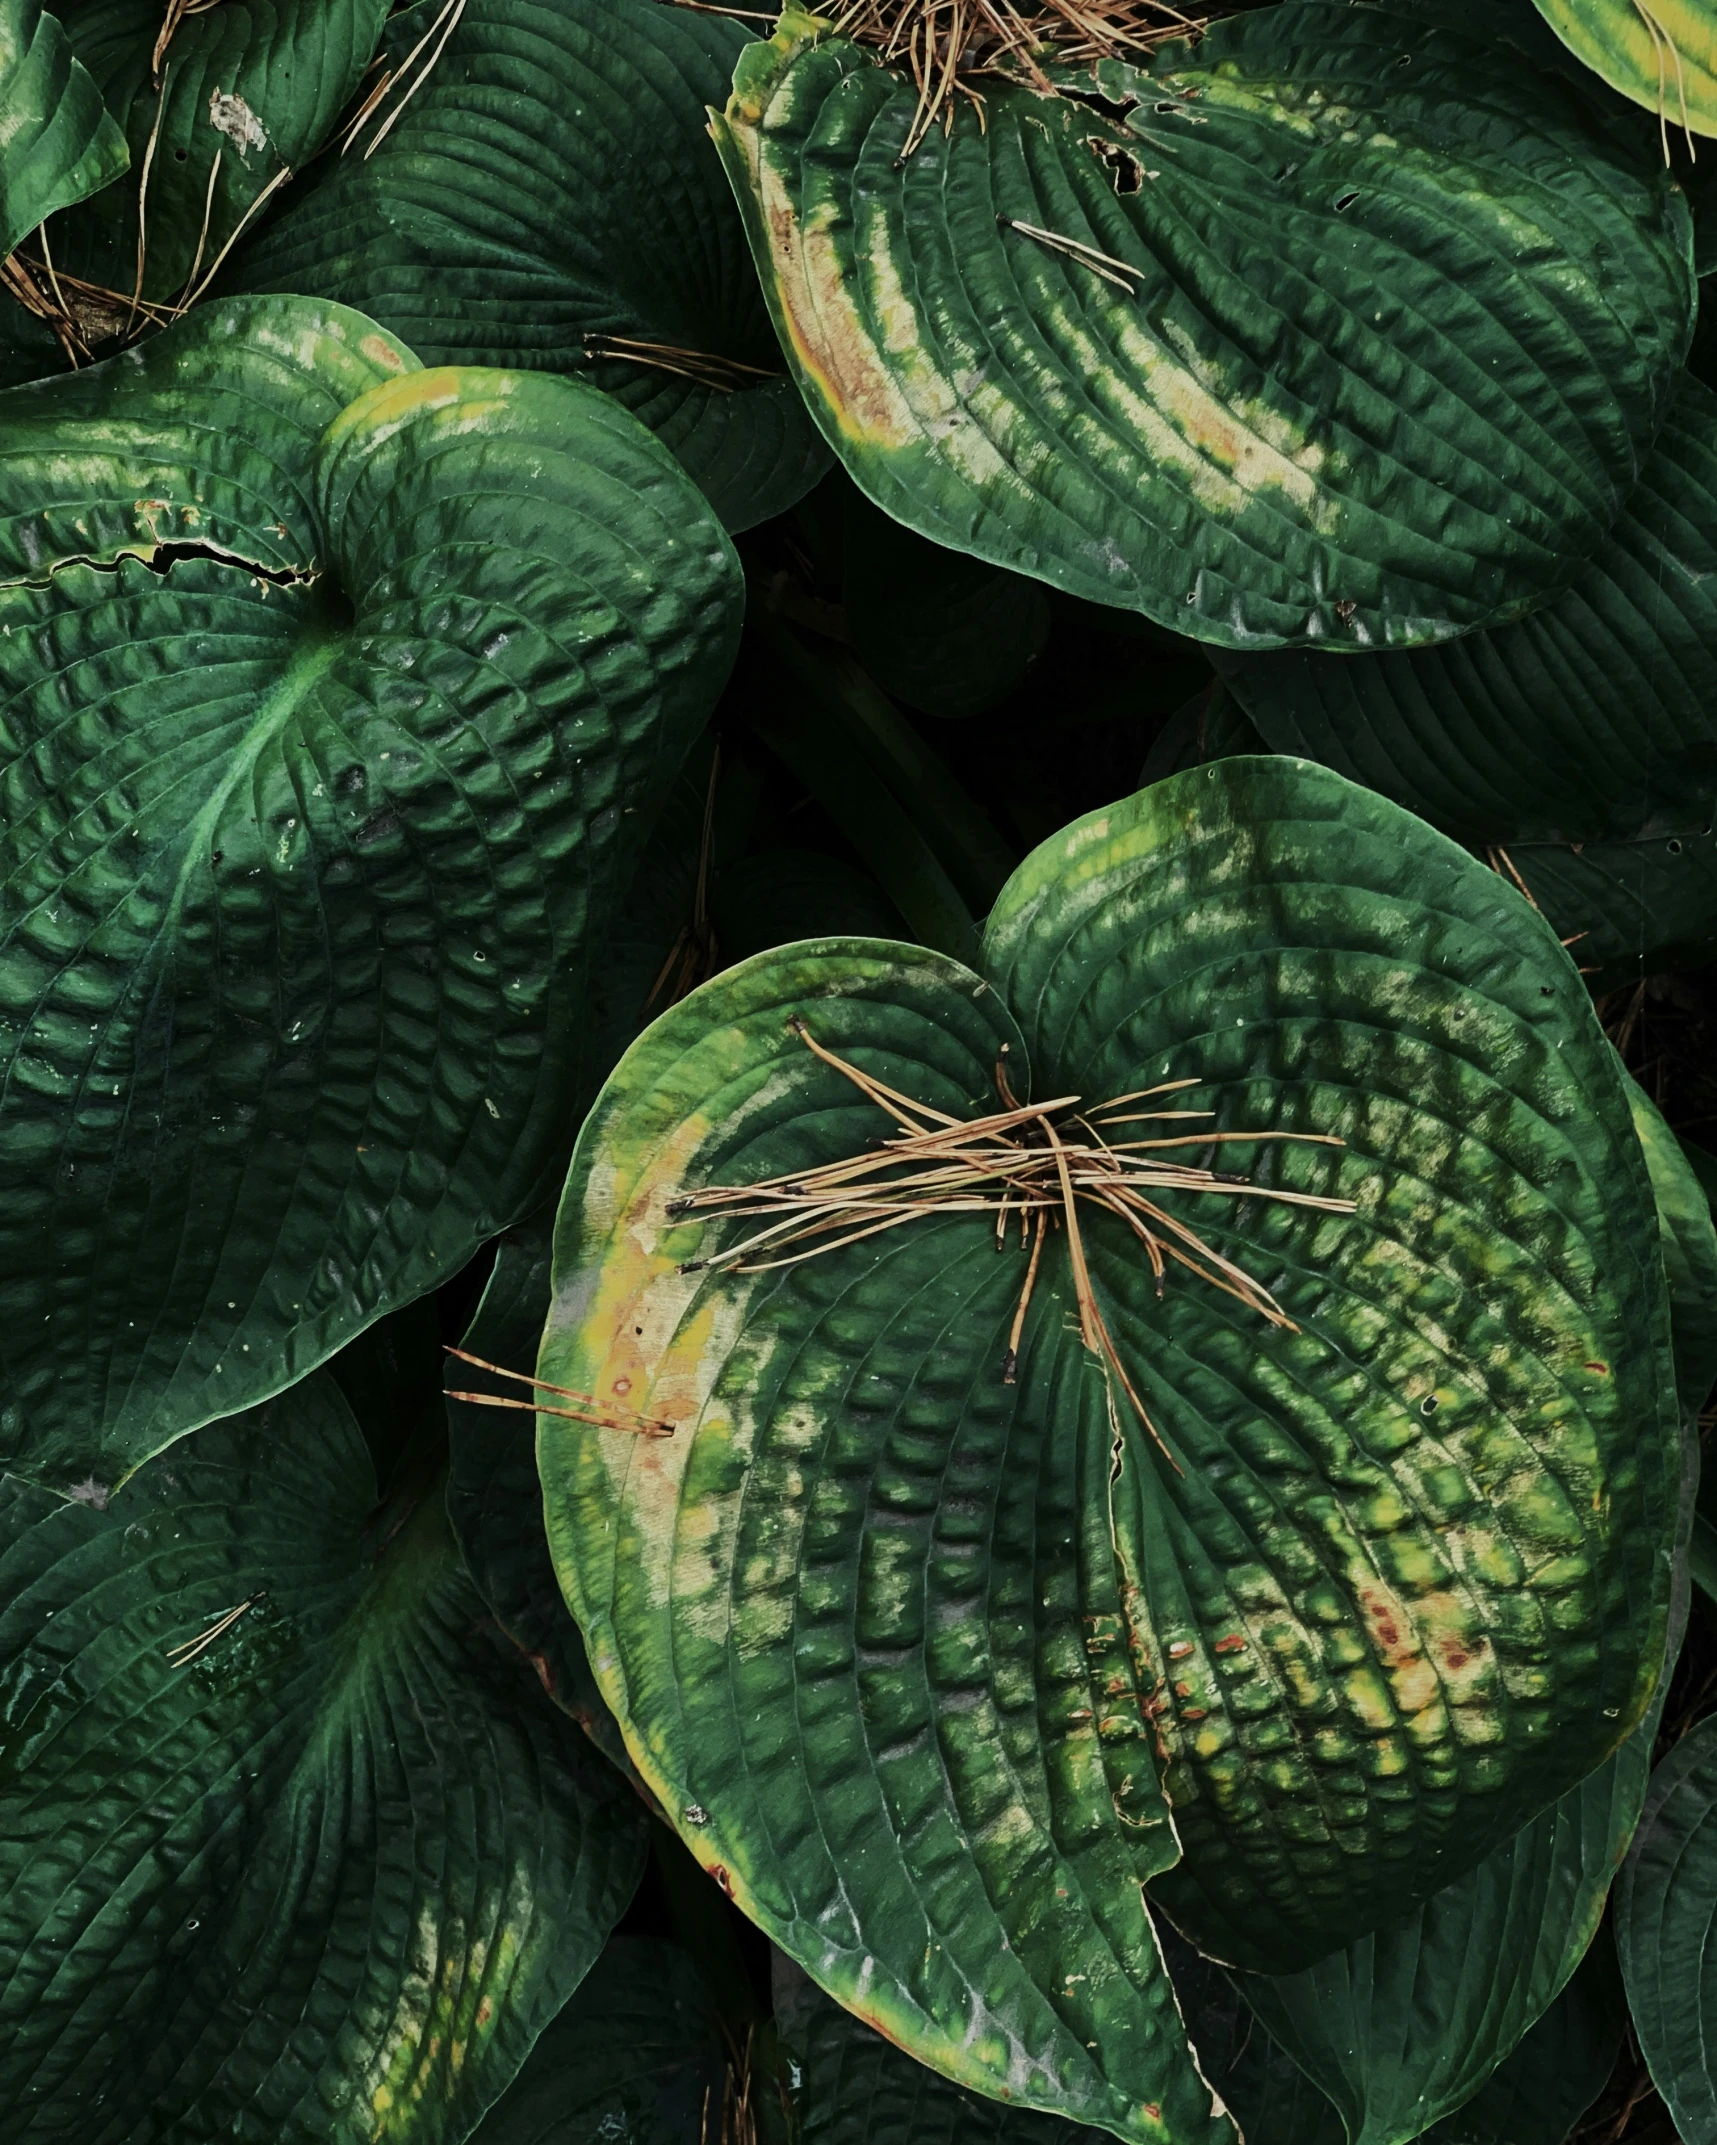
[717,0,1693,648]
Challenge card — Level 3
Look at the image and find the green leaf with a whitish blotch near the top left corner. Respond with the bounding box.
[52,0,388,306]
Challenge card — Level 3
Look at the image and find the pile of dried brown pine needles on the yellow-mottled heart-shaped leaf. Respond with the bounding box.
[667,1017,1354,1452]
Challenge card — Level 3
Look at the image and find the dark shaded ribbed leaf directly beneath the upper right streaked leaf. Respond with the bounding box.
[1221,375,1717,840]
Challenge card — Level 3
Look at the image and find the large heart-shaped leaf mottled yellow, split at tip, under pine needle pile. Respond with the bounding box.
[539,759,1681,2141]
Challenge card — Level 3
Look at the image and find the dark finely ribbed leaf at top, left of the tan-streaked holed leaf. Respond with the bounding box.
[236,0,828,528]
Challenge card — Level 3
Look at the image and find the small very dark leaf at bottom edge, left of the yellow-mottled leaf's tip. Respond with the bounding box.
[470,1937,725,2145]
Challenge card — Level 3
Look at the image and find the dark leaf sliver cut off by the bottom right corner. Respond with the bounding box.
[1616,1720,1717,2145]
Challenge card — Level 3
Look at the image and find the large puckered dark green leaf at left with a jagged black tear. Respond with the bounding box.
[0,298,740,1482]
